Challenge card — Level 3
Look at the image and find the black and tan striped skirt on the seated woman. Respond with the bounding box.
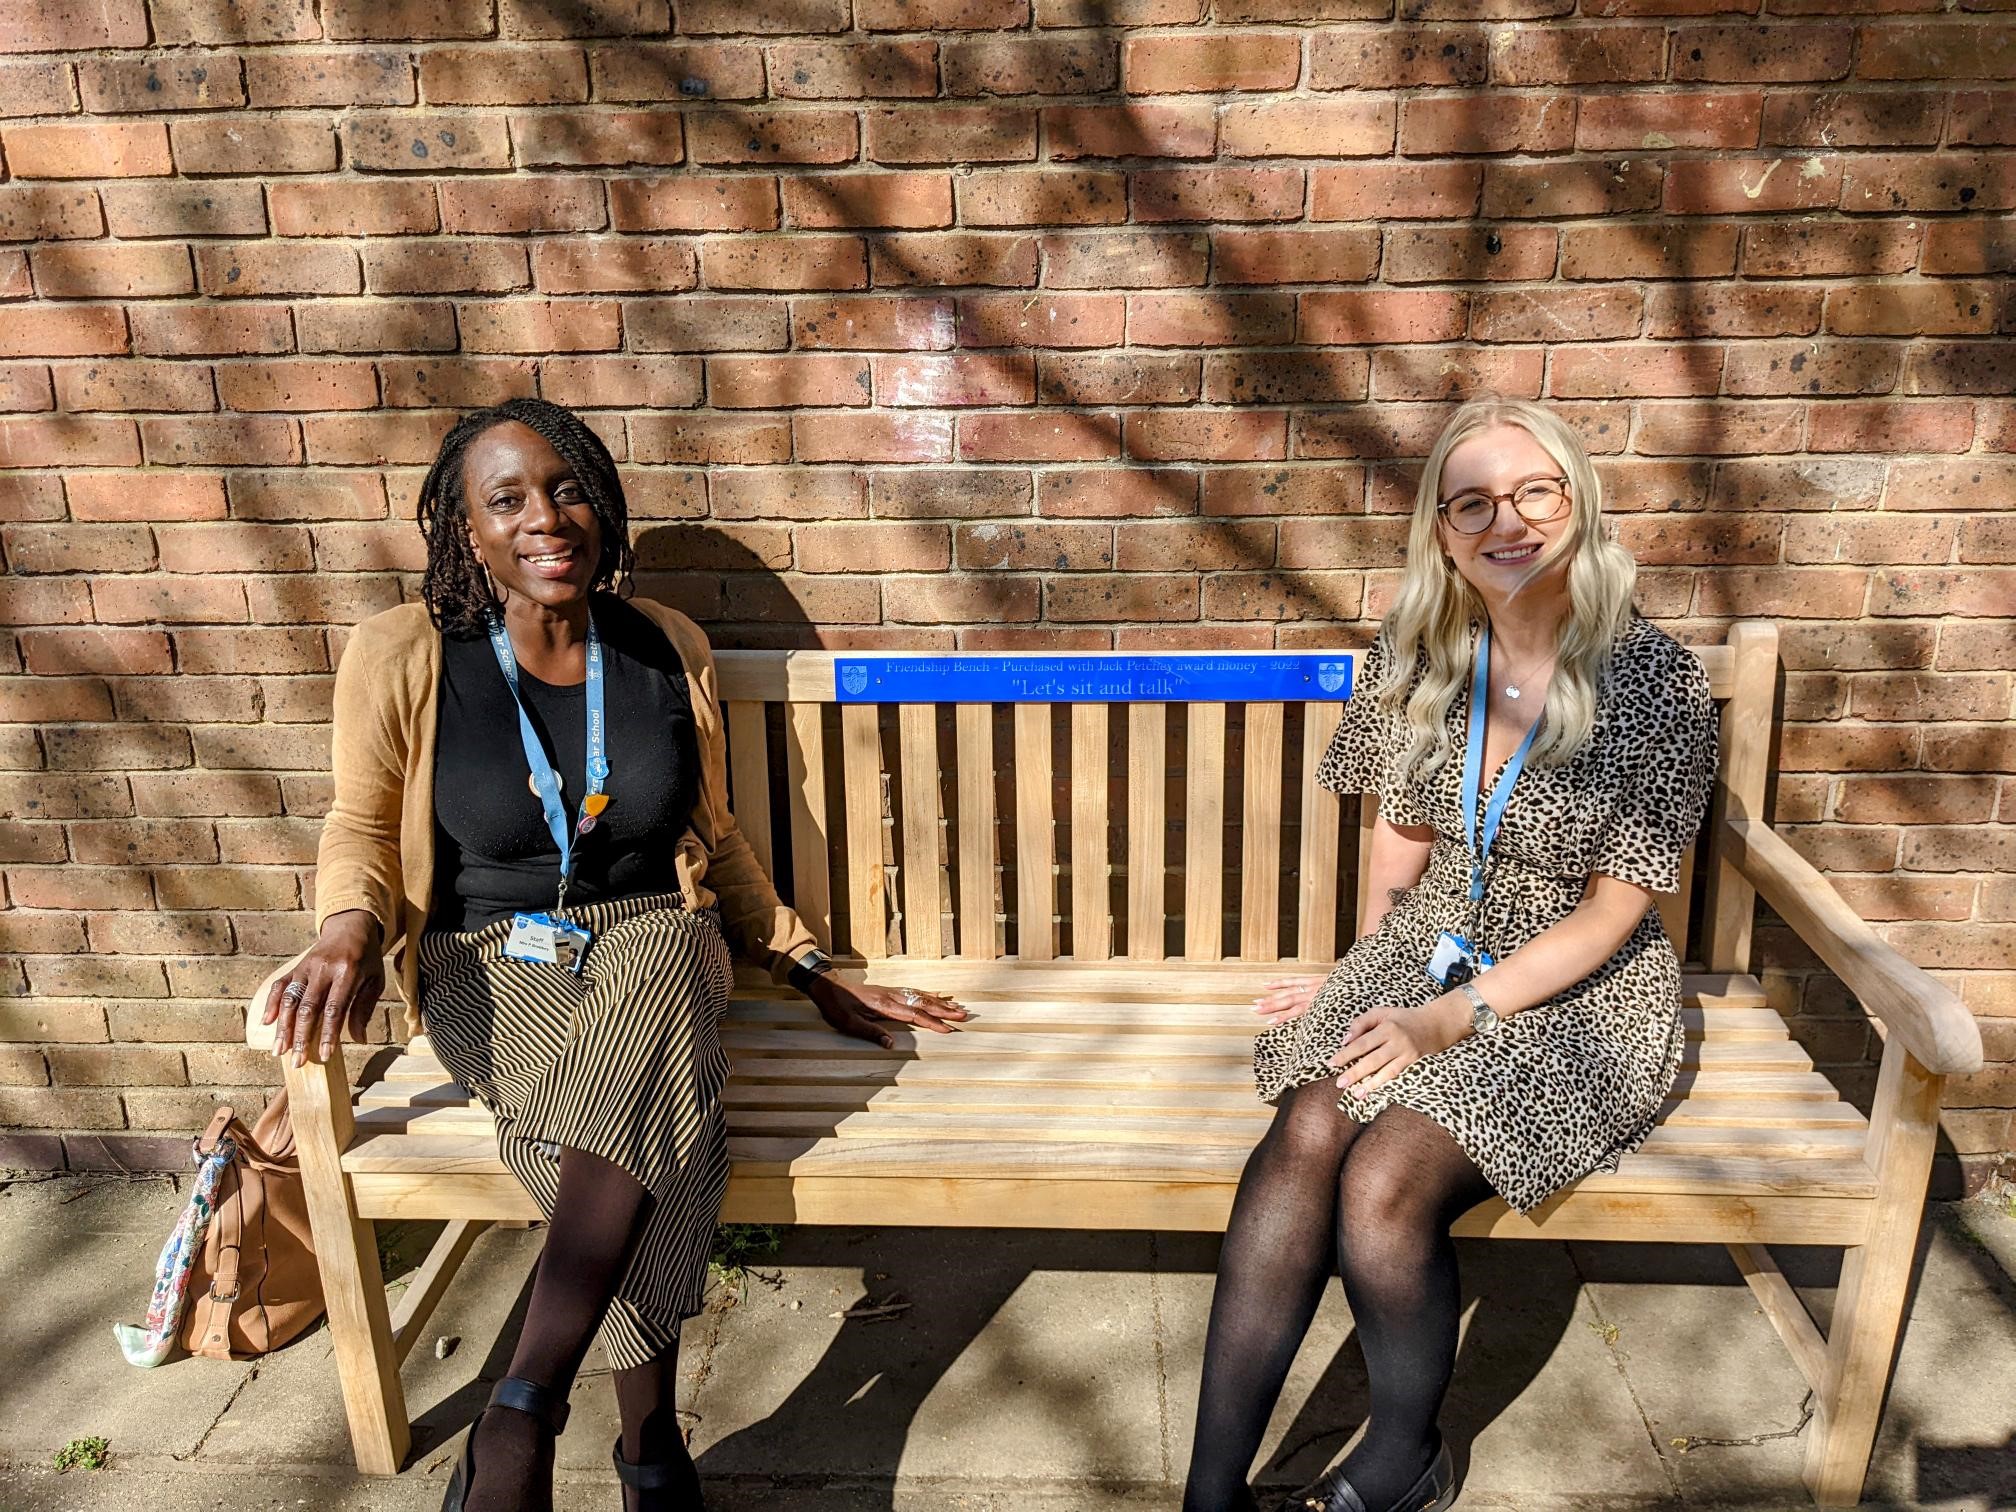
[419,893,734,1371]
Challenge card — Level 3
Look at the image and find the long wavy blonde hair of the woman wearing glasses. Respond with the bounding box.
[1371,397,1637,776]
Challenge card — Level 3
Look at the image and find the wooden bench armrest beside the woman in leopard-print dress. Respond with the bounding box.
[1724,818,1982,1077]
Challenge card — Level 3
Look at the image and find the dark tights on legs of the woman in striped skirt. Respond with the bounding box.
[466,1149,700,1512]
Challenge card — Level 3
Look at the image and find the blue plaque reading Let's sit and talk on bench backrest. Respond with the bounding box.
[833,651,1353,704]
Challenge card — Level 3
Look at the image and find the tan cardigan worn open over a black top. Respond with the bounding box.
[314,599,816,1038]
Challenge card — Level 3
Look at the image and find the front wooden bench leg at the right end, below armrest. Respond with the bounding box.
[1806,1040,1941,1506]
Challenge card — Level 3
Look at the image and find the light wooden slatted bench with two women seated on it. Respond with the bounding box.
[248,623,1982,1506]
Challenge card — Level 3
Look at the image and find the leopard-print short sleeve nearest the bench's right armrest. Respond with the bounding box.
[1589,647,1718,893]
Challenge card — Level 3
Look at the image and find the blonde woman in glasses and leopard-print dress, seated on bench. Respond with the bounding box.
[1183,399,1716,1512]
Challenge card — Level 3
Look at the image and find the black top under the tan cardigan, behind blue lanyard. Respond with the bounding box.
[427,593,700,929]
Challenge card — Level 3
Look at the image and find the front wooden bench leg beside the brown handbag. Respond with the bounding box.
[286,1054,413,1476]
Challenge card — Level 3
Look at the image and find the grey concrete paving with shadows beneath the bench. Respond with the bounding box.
[0,1177,2016,1512]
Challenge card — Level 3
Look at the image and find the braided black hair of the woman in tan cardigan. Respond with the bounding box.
[419,399,637,639]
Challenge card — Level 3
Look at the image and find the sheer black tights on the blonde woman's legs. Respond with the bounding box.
[1183,1077,1490,1512]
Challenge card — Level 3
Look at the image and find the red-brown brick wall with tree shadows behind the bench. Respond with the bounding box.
[0,0,2016,1173]
